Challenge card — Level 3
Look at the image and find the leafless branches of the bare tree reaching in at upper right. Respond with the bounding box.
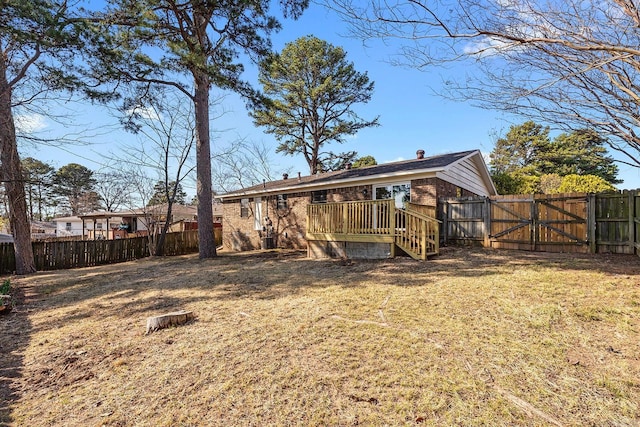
[329,0,640,167]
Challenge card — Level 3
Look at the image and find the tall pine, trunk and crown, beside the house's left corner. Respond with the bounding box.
[96,0,308,258]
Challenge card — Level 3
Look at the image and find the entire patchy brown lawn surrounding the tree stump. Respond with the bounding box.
[0,249,640,426]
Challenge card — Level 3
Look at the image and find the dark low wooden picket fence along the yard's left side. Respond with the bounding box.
[0,230,198,274]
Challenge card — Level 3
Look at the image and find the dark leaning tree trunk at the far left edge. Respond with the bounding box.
[0,51,36,274]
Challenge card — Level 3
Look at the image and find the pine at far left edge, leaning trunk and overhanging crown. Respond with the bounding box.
[0,0,86,274]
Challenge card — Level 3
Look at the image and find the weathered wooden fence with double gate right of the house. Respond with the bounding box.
[439,190,640,254]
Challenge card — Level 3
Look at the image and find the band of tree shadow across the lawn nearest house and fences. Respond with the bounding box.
[17,248,640,320]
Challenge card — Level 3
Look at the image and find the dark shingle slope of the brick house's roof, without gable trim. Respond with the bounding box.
[221,150,477,198]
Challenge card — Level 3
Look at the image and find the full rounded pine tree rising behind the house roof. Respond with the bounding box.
[251,36,378,174]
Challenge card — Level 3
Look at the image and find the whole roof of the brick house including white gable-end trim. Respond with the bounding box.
[218,150,495,200]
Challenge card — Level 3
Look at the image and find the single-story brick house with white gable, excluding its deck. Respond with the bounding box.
[219,150,496,255]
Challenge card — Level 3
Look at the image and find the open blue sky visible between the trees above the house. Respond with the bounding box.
[16,3,640,194]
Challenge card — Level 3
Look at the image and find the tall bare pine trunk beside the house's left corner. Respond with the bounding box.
[194,71,217,259]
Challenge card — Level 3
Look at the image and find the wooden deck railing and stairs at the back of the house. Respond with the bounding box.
[307,199,440,260]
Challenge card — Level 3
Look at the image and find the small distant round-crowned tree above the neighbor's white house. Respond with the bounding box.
[53,163,100,215]
